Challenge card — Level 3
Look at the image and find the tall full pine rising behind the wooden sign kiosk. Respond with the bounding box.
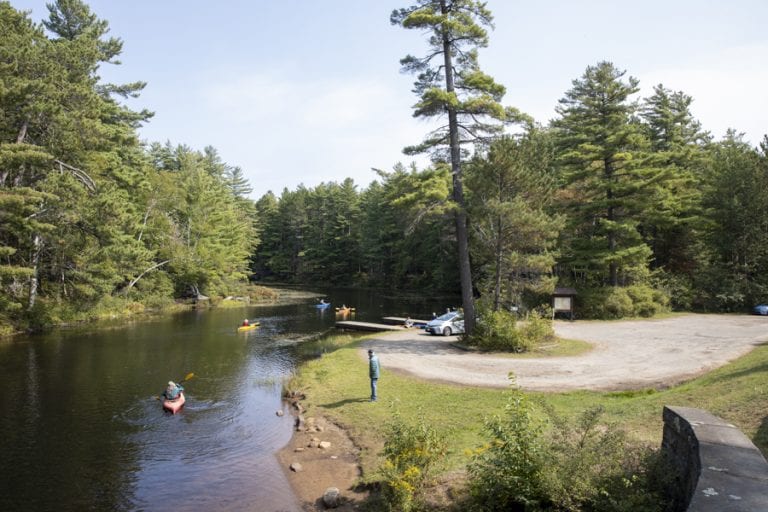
[553,62,661,286]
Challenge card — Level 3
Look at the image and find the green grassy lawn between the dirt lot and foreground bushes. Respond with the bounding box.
[288,337,768,480]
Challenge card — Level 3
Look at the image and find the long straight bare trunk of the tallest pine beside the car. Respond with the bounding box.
[440,0,475,335]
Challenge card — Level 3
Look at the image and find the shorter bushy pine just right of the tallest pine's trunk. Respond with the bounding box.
[467,129,563,311]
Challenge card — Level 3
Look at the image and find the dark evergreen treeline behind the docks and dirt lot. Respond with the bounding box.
[254,62,768,317]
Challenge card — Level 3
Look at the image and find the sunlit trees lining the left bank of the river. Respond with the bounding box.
[0,0,257,330]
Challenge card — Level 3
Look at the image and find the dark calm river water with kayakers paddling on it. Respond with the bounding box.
[0,290,455,512]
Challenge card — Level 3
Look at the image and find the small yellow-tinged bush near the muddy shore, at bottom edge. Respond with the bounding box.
[379,411,447,512]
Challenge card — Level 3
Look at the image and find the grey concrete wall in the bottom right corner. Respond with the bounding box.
[661,406,768,512]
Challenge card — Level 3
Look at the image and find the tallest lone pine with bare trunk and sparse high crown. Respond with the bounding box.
[390,0,505,334]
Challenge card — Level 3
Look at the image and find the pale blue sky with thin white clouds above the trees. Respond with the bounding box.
[10,0,768,199]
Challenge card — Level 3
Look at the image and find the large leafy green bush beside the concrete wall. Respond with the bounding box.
[468,391,665,512]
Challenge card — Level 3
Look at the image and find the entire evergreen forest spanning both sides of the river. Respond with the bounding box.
[0,0,768,332]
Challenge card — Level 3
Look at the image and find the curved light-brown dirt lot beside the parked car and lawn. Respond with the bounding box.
[361,314,768,391]
